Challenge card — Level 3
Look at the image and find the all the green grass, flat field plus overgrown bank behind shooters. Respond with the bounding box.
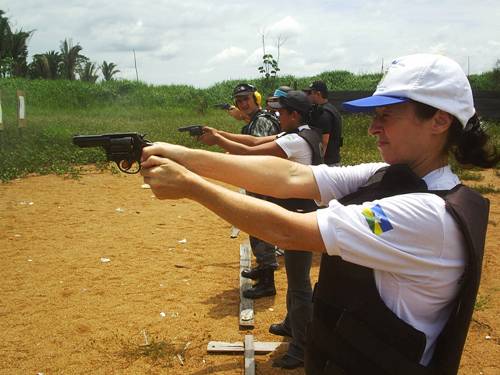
[0,76,500,182]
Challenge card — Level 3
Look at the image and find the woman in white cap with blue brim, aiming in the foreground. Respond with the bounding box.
[142,54,500,375]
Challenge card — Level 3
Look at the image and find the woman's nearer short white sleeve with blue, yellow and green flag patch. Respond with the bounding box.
[316,193,461,276]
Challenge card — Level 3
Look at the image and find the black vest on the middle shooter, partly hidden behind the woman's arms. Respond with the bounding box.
[269,128,323,212]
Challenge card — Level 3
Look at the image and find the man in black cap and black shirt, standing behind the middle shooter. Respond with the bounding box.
[304,81,342,166]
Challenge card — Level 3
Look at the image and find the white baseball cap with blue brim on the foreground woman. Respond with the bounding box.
[343,53,476,128]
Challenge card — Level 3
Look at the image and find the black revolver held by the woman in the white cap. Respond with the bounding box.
[73,133,153,174]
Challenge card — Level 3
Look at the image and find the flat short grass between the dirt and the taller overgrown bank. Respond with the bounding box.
[0,105,380,181]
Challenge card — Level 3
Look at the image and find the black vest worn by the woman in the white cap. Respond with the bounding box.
[306,165,489,375]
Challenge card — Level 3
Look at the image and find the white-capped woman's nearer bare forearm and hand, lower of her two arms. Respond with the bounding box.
[141,156,325,252]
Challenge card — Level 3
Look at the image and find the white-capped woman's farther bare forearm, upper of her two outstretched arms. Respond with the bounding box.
[142,142,320,201]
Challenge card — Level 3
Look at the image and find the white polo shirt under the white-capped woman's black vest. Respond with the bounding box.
[311,163,466,365]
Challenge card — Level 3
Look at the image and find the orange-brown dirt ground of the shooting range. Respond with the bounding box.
[0,169,500,375]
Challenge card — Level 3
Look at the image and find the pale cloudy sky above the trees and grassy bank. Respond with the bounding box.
[0,0,500,87]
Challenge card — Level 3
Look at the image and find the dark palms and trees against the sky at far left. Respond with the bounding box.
[0,10,119,82]
